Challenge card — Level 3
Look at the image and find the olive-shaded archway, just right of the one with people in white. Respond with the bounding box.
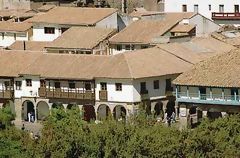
[37,101,50,120]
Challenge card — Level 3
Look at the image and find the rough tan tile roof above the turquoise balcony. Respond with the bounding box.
[174,49,240,88]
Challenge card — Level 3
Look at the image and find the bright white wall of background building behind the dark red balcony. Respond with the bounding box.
[165,0,240,19]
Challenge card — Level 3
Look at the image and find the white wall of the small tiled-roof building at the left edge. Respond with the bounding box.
[0,32,28,47]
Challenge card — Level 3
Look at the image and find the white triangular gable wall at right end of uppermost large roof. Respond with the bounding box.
[96,12,118,29]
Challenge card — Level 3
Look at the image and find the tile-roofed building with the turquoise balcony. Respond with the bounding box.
[173,50,240,127]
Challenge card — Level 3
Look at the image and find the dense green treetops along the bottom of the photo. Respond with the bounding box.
[0,109,240,158]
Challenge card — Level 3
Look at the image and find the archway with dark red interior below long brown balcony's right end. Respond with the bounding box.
[82,105,96,122]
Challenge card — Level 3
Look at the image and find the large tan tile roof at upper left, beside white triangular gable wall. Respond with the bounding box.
[29,7,117,25]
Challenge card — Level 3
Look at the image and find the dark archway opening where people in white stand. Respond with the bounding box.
[22,100,35,121]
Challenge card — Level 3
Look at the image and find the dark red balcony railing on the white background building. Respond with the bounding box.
[212,12,240,20]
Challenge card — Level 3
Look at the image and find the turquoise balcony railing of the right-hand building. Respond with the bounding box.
[176,92,240,105]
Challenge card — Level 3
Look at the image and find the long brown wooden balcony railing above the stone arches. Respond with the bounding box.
[38,88,95,100]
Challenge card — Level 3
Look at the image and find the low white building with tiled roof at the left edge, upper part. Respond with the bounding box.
[0,21,32,47]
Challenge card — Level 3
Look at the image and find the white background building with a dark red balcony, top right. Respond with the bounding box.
[164,0,240,24]
